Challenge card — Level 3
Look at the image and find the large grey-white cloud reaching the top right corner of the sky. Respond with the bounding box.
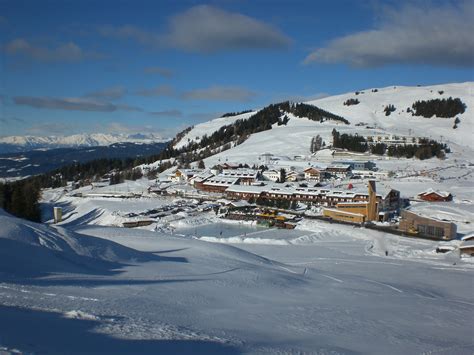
[304,1,474,67]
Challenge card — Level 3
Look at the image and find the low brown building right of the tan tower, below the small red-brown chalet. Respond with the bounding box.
[398,210,457,239]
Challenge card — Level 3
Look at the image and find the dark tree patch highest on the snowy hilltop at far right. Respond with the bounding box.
[412,97,466,118]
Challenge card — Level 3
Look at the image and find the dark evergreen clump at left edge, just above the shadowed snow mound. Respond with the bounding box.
[0,179,41,222]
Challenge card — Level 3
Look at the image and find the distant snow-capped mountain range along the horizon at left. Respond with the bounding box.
[0,133,167,153]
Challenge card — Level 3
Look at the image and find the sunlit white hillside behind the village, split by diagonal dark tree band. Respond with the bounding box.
[176,82,474,162]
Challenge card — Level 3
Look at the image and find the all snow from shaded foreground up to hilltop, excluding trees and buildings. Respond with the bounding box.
[0,83,474,354]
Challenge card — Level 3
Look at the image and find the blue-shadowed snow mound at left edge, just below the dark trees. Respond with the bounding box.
[0,209,151,278]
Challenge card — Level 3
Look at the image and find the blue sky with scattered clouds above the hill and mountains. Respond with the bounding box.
[0,0,474,137]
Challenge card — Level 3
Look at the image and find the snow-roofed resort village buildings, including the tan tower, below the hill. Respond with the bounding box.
[161,161,456,239]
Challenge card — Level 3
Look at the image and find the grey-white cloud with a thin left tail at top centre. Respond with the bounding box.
[98,5,291,53]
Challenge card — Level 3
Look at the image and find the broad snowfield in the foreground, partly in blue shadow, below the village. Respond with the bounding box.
[0,207,474,354]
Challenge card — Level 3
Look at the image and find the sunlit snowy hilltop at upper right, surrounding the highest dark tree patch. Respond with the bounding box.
[308,82,474,148]
